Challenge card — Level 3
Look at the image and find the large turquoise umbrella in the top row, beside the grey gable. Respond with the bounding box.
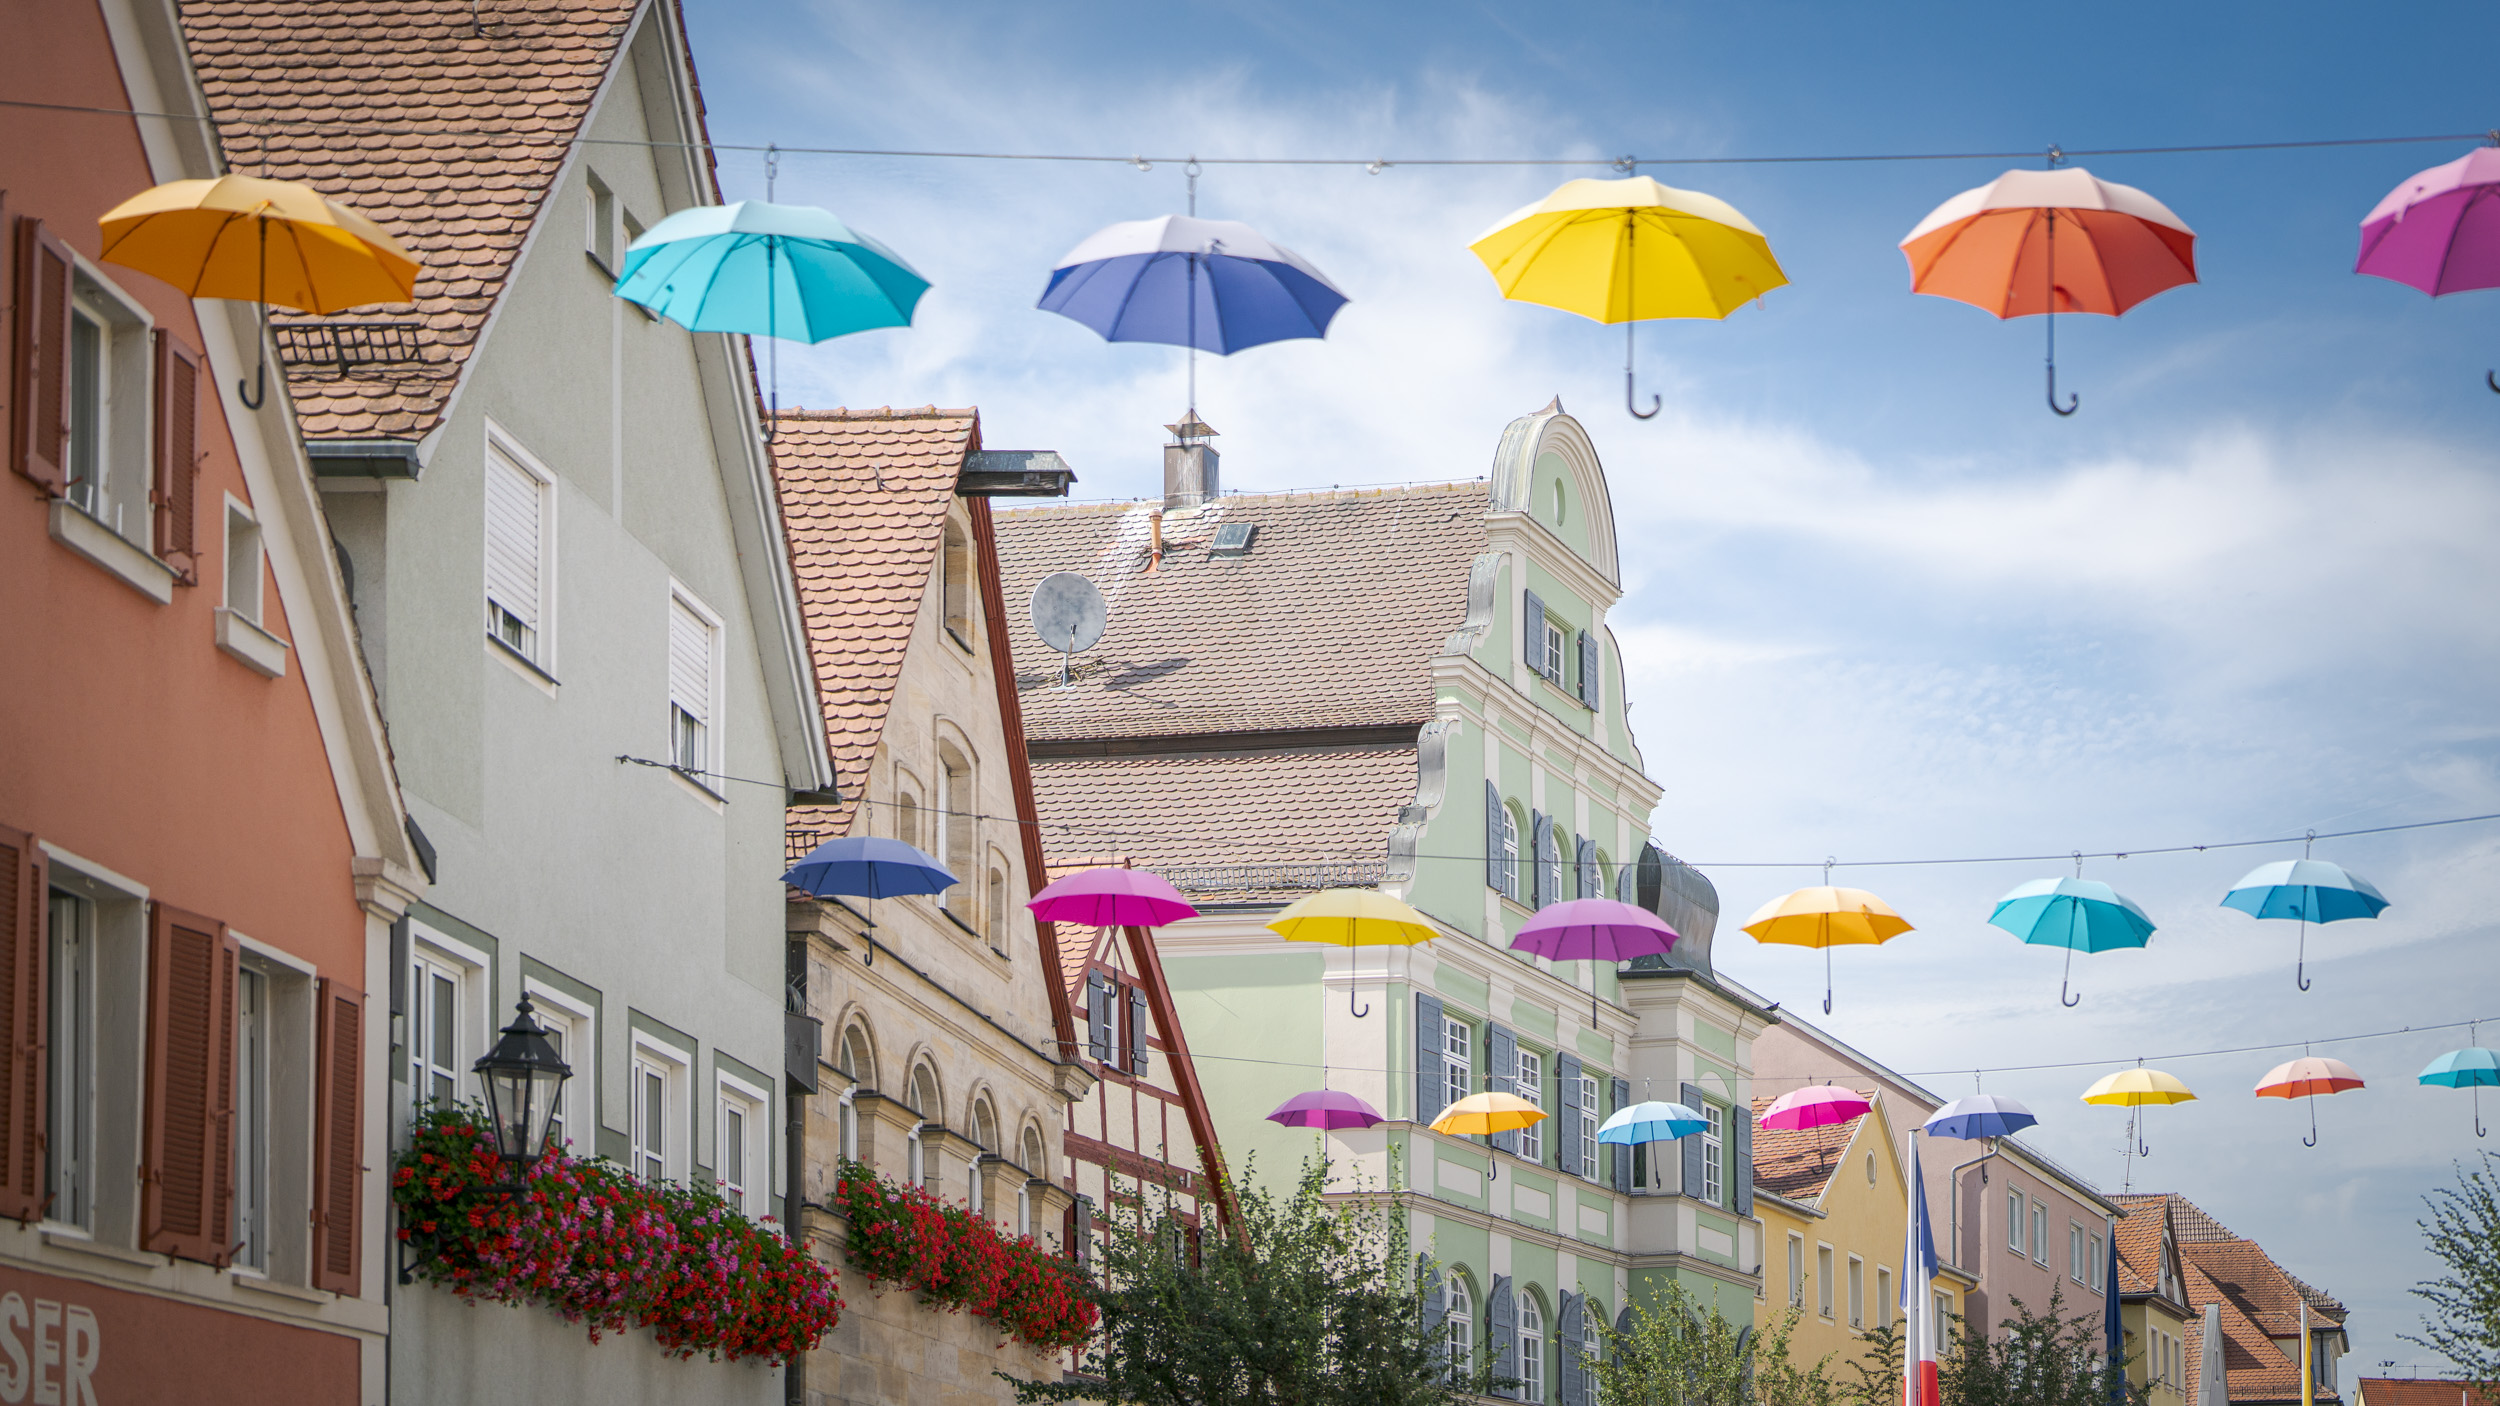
[615,200,930,438]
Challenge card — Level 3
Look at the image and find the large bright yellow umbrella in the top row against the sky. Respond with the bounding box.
[1468,175,1788,420]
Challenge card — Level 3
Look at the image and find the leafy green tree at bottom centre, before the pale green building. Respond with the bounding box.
[1000,1161,1478,1406]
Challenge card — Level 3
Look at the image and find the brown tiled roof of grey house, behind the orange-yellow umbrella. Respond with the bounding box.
[180,0,635,440]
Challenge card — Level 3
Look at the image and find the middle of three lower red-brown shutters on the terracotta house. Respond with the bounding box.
[140,903,240,1266]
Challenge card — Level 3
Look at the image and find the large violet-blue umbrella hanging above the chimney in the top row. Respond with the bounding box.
[1038,215,1345,410]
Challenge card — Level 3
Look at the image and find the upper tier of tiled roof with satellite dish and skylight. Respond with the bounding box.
[998,483,1485,741]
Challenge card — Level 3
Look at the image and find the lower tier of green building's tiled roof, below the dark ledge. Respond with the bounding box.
[1033,746,1415,903]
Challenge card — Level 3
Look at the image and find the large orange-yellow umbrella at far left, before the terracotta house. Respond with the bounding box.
[98,175,418,410]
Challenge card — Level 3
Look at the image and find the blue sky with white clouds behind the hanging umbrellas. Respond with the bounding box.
[690,0,2500,1366]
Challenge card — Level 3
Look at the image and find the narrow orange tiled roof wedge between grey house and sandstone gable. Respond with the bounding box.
[773,405,980,846]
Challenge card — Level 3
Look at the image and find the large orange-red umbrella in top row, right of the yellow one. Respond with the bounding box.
[1900,165,2195,415]
